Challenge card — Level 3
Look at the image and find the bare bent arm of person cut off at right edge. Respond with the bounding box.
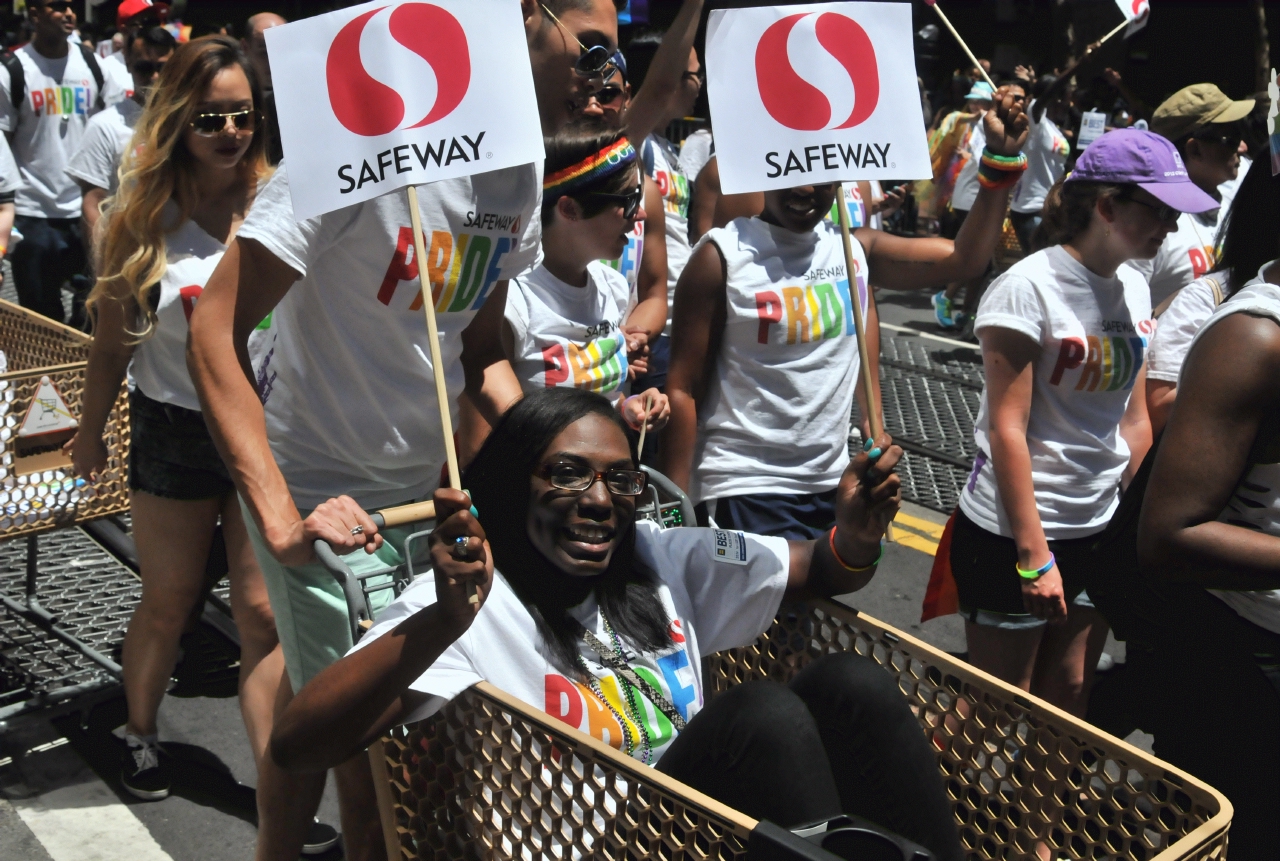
[1138,313,1280,590]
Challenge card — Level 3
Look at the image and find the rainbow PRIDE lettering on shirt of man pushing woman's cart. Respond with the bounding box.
[378,225,520,313]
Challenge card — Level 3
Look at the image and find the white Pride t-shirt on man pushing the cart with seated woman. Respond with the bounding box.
[239,162,541,509]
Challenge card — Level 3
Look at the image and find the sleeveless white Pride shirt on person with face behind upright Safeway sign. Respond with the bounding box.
[690,217,868,502]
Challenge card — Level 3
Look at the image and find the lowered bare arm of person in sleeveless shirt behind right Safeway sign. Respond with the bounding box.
[660,242,727,493]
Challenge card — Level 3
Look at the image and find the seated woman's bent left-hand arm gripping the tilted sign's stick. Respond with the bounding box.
[271,489,493,771]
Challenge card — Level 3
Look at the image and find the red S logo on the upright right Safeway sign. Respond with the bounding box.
[755,12,879,132]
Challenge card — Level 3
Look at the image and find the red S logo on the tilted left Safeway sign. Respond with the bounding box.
[325,3,471,137]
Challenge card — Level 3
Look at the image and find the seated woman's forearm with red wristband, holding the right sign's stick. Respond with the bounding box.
[786,434,902,599]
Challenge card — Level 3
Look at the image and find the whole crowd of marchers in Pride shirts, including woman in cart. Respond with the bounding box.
[0,0,1280,860]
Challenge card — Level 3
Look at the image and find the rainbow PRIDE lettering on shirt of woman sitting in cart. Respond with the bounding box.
[544,620,703,750]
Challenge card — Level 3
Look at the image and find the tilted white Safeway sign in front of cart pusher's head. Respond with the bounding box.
[266,0,543,221]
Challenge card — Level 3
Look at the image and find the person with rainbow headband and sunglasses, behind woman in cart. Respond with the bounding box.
[462,120,668,431]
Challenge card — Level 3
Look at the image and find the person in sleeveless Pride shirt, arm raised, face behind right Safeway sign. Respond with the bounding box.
[662,85,1027,539]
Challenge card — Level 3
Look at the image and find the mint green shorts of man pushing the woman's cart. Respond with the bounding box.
[241,500,430,693]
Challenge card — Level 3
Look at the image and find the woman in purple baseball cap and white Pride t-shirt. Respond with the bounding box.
[950,129,1217,715]
